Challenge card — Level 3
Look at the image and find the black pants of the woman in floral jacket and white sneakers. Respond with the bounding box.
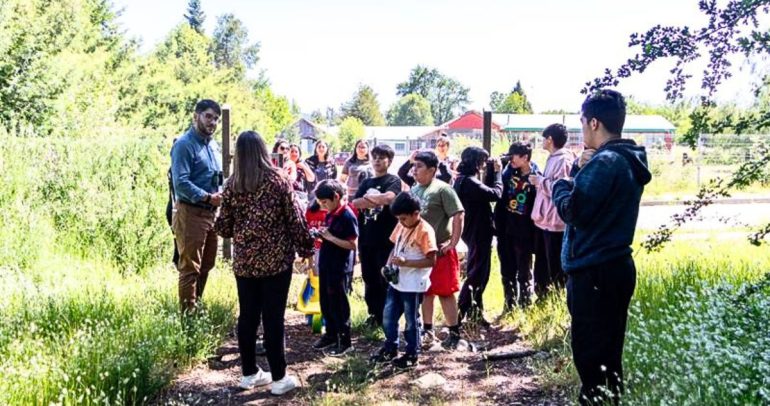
[235,269,291,381]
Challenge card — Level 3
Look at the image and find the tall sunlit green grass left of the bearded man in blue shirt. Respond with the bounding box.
[0,135,235,405]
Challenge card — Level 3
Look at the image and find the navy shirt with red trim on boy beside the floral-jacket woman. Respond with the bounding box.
[318,206,358,277]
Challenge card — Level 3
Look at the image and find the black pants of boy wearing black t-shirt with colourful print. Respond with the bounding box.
[497,234,532,309]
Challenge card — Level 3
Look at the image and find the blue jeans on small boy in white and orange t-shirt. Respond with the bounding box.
[382,286,422,355]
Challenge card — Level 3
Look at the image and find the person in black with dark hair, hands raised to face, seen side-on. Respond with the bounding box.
[454,147,503,327]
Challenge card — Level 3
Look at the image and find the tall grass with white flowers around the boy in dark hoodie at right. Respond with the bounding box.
[504,240,770,405]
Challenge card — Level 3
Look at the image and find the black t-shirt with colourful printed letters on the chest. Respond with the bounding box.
[495,165,538,248]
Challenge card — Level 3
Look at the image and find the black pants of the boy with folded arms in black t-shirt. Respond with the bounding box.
[358,242,393,325]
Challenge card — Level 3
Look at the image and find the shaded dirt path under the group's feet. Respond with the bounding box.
[155,311,568,405]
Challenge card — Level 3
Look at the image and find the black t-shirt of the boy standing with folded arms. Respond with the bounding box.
[355,173,401,249]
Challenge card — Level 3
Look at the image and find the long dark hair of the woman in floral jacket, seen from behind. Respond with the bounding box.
[233,130,278,193]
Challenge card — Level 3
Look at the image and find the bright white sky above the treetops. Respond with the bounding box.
[114,0,757,113]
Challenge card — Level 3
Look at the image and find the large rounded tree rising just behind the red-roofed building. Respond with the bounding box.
[396,65,470,125]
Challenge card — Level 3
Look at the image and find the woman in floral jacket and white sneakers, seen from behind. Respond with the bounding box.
[214,131,313,395]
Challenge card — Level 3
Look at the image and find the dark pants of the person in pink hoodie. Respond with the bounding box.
[535,230,567,296]
